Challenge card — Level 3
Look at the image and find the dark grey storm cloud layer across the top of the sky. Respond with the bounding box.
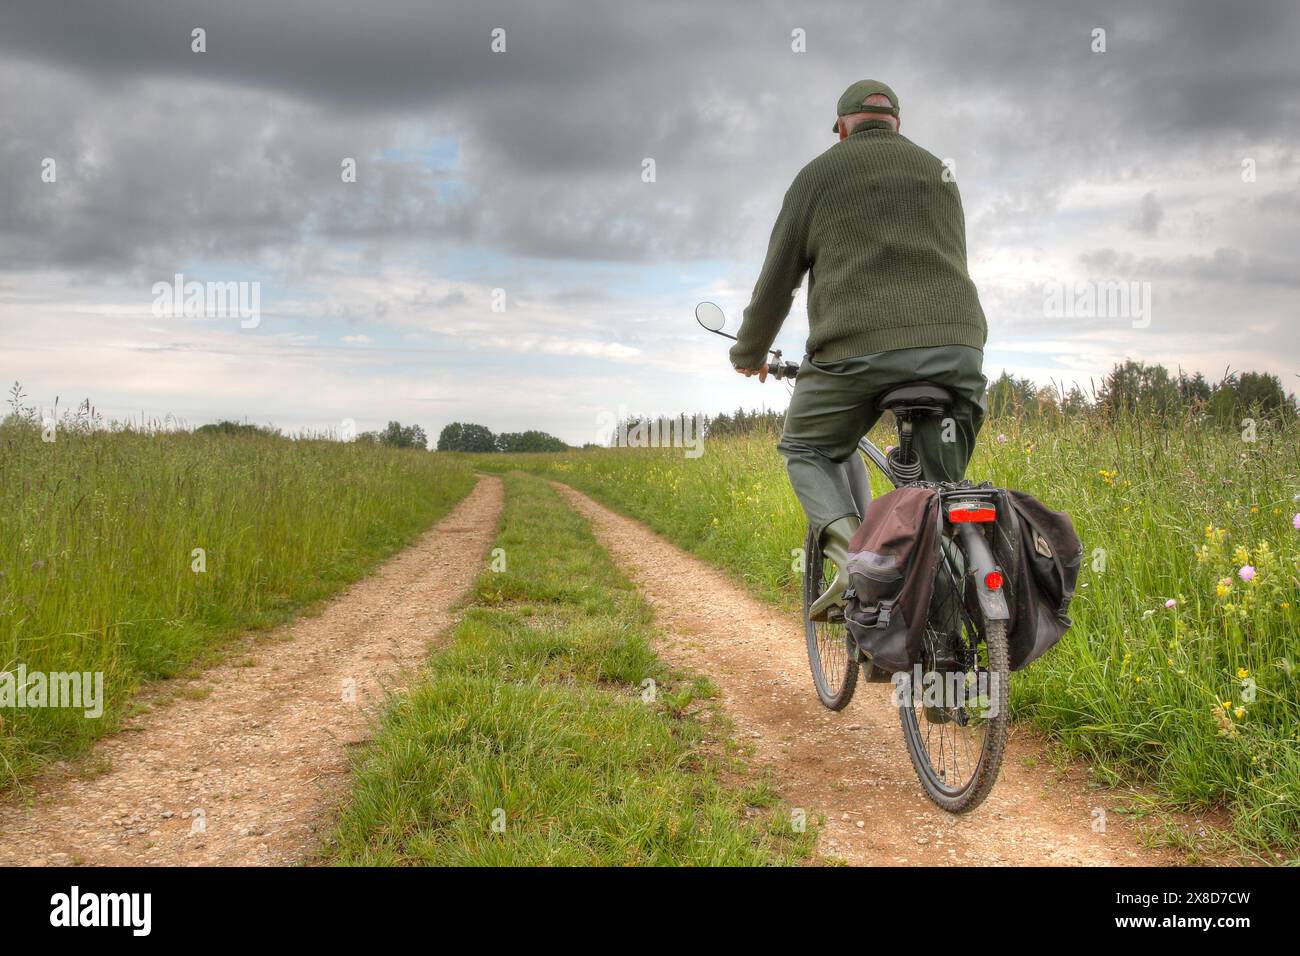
[0,0,1300,268]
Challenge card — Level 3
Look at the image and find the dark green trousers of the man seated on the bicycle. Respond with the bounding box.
[777,345,988,533]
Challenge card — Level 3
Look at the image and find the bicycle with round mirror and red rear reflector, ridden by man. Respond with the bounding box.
[696,302,1010,813]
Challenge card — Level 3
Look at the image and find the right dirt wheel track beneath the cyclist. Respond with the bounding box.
[556,484,1179,865]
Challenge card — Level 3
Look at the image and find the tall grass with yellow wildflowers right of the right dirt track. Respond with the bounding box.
[480,416,1300,858]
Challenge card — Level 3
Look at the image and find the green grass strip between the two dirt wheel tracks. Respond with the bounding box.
[329,475,813,866]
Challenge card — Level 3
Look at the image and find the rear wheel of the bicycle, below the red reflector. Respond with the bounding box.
[896,541,1010,813]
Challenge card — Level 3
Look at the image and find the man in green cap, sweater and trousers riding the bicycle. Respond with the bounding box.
[731,79,988,620]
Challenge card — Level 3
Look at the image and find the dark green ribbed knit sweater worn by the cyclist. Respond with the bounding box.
[731,120,988,368]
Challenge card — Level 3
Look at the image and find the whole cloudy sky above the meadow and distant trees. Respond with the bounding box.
[0,0,1300,442]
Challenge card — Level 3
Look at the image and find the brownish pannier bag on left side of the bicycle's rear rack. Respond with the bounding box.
[844,485,939,674]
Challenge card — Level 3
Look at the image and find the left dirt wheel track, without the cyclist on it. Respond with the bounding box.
[0,477,502,866]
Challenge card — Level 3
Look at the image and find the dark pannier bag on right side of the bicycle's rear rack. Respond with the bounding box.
[993,489,1083,670]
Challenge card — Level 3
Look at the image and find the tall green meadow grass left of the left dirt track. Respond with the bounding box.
[0,420,473,788]
